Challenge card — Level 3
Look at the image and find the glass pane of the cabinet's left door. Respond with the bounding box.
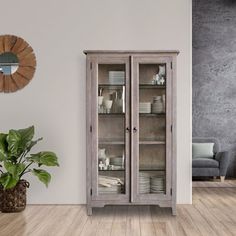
[97,64,126,195]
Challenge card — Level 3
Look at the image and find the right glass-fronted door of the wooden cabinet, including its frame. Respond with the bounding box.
[131,57,171,202]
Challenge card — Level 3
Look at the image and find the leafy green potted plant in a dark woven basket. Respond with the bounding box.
[0,126,59,212]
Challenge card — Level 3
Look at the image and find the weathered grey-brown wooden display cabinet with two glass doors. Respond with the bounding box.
[84,51,178,215]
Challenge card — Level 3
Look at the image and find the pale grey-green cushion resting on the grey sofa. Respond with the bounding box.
[192,143,214,159]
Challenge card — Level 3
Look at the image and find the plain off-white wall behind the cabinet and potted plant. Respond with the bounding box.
[0,0,191,204]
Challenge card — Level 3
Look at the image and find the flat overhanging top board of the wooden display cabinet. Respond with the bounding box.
[84,50,179,55]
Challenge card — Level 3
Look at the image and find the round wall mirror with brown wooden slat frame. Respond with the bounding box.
[0,35,36,93]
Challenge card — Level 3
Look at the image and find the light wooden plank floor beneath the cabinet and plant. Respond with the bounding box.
[0,188,236,236]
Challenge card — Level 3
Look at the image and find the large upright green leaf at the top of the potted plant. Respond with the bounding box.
[7,126,34,157]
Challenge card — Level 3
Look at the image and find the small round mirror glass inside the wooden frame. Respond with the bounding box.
[0,52,19,75]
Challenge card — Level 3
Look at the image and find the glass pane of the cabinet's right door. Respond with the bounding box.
[138,64,166,194]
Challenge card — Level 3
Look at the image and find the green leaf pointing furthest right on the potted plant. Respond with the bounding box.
[27,152,59,166]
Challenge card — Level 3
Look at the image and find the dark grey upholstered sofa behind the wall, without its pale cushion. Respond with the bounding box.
[192,138,230,182]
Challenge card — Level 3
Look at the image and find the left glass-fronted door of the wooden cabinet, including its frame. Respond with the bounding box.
[91,57,130,201]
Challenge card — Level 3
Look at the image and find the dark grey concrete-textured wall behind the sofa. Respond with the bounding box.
[193,0,236,177]
